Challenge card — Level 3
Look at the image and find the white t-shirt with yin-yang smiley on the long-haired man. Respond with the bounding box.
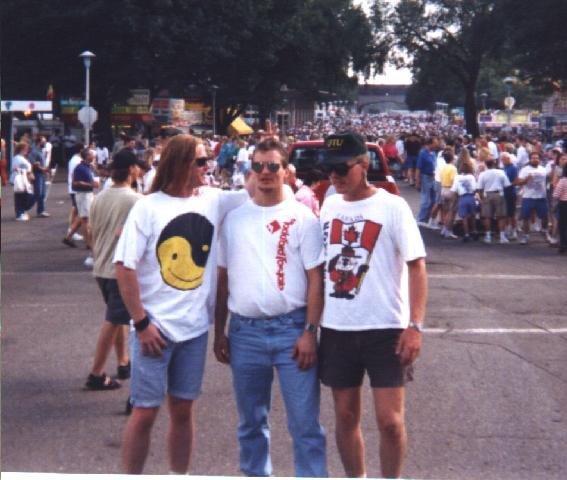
[113,187,249,342]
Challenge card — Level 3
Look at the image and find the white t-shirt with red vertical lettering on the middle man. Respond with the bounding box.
[219,199,323,318]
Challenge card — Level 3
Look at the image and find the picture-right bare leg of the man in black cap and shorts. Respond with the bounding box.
[372,387,407,478]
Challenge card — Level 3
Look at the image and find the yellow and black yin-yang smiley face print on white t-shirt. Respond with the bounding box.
[156,213,214,290]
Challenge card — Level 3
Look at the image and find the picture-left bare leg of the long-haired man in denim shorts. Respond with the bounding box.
[122,407,159,474]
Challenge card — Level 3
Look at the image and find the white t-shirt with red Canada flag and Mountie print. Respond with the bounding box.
[320,189,425,330]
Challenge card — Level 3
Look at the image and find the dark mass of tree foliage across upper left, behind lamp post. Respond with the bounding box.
[1,0,387,137]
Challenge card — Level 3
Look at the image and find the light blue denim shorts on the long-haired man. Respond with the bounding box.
[130,332,208,408]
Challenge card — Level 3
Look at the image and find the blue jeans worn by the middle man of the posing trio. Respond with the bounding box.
[229,309,328,477]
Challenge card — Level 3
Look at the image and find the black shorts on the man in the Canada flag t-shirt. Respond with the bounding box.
[319,327,406,388]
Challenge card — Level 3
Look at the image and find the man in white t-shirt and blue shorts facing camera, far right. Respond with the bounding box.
[517,152,549,245]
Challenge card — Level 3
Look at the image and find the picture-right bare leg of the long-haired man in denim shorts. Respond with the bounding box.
[168,396,195,475]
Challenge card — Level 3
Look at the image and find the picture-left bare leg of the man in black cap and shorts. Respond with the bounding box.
[333,387,366,478]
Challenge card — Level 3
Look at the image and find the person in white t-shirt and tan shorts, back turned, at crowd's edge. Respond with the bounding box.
[477,157,511,243]
